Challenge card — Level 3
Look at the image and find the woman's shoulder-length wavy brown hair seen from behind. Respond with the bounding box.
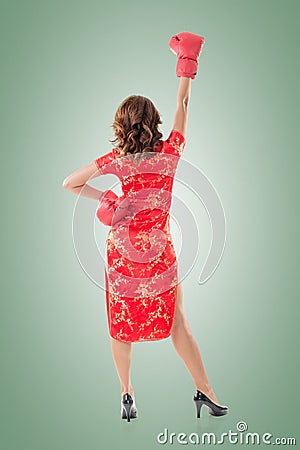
[109,95,163,159]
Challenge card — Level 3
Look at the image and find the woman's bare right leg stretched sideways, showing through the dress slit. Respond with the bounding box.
[171,283,219,405]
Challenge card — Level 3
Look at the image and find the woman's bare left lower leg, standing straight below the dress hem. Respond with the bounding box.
[110,337,134,396]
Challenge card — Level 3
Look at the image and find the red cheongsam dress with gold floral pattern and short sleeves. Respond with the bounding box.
[94,129,186,342]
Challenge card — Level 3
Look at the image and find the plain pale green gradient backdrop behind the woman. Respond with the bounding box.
[1,0,299,450]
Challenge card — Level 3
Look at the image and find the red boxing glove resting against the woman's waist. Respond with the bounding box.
[96,189,129,226]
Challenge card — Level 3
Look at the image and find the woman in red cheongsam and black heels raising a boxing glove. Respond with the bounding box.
[63,32,228,422]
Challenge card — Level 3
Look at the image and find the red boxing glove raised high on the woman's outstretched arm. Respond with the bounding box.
[169,31,205,80]
